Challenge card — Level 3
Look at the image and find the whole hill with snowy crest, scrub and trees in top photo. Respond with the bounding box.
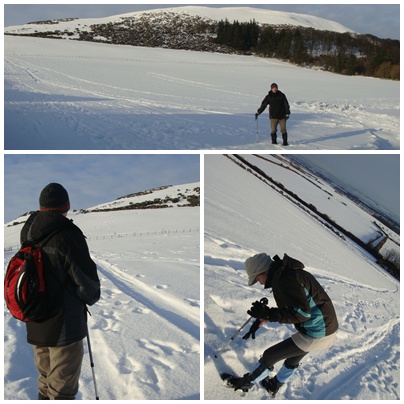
[5,6,400,80]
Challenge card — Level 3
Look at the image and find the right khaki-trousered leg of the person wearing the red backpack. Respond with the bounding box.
[48,340,84,400]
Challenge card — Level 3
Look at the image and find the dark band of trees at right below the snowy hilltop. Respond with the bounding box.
[216,20,400,80]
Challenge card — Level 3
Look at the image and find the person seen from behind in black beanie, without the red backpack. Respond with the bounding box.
[20,183,100,400]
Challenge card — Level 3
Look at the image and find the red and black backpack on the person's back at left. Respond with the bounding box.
[4,229,61,322]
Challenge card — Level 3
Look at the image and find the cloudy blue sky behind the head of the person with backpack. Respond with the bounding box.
[4,154,200,223]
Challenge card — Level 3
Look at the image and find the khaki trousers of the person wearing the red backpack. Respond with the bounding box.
[33,340,83,400]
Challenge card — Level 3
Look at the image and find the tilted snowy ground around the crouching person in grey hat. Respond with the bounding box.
[204,155,400,400]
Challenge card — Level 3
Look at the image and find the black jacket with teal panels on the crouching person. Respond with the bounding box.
[265,254,338,338]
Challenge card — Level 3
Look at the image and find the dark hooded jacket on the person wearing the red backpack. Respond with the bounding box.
[21,211,100,347]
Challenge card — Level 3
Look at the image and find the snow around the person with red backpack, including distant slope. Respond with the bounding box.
[4,183,200,400]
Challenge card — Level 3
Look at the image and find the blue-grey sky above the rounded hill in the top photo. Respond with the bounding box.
[4,3,400,39]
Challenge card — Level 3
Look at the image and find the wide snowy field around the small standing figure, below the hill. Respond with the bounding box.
[4,36,400,150]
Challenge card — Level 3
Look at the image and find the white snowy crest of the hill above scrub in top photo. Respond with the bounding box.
[5,6,353,34]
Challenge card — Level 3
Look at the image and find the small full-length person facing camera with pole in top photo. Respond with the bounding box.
[255,83,290,146]
